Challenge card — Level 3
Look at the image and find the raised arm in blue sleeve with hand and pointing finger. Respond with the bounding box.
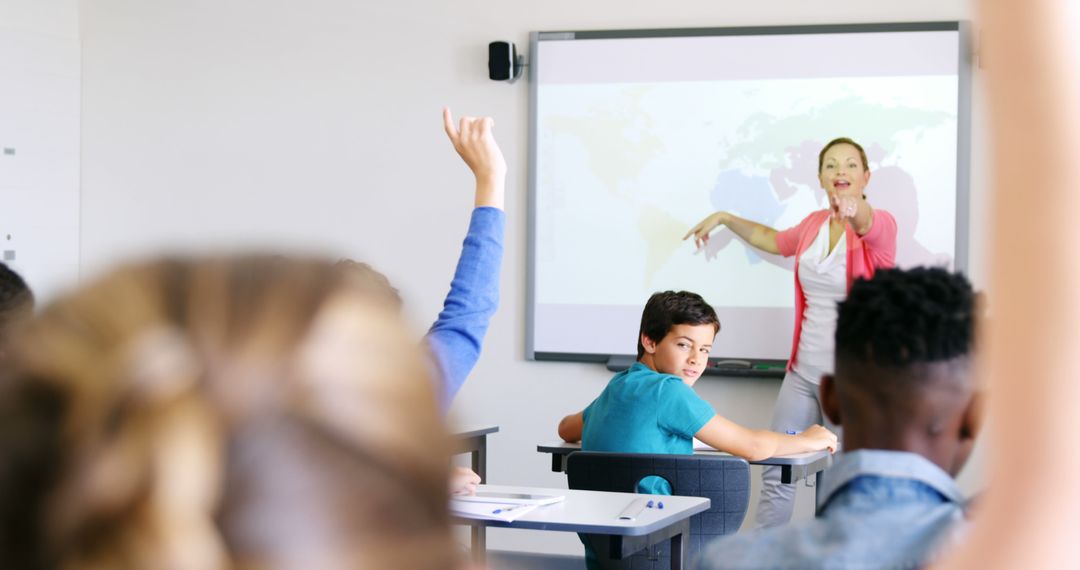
[427,109,507,407]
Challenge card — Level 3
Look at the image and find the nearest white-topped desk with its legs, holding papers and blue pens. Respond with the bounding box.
[455,485,711,570]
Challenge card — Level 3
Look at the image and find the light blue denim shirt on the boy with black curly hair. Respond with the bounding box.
[700,449,964,569]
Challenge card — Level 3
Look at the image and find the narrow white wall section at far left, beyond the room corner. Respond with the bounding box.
[0,0,81,299]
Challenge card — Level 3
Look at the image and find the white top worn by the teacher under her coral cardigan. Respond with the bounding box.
[795,220,848,384]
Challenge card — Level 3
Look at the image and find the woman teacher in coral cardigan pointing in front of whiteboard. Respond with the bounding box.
[683,138,896,528]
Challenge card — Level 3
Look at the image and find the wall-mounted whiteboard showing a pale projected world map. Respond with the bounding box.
[527,22,970,361]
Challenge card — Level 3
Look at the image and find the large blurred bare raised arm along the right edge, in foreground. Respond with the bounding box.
[936,0,1080,570]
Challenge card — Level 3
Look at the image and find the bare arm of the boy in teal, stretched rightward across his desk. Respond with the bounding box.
[694,416,836,461]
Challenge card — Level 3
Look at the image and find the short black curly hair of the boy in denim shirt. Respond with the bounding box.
[836,267,975,368]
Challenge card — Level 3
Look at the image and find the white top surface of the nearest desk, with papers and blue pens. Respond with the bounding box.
[458,485,710,537]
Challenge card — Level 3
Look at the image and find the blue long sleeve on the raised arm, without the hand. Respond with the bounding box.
[427,207,507,409]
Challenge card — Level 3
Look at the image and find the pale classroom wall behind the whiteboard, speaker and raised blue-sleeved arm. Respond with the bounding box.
[80,0,986,554]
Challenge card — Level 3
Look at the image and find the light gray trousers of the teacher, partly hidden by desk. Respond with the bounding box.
[755,370,842,528]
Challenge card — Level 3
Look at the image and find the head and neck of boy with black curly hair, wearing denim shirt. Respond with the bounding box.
[821,268,978,475]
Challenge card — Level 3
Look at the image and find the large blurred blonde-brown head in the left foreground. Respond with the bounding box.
[0,256,458,569]
